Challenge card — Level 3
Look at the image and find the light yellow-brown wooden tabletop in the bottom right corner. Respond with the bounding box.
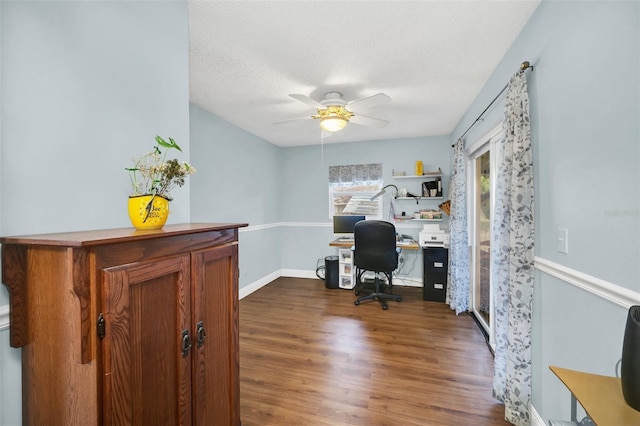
[549,366,640,426]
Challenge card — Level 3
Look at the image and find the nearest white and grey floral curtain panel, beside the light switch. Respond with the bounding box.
[491,71,534,425]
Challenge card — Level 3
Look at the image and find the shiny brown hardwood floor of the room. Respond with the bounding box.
[240,278,508,426]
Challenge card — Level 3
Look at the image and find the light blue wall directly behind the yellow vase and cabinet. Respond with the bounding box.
[0,1,189,426]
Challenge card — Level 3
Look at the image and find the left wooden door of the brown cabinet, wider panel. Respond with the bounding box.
[102,255,192,426]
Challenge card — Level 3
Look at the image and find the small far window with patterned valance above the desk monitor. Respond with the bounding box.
[329,164,382,219]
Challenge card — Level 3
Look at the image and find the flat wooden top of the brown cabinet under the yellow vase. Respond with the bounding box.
[0,223,248,247]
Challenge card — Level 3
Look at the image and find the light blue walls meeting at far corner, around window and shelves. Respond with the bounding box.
[190,105,451,289]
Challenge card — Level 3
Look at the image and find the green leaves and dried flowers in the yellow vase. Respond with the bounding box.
[127,136,196,201]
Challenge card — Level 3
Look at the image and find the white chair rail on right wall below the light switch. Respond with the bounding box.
[535,256,640,309]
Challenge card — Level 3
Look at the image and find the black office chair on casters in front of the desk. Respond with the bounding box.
[353,220,402,310]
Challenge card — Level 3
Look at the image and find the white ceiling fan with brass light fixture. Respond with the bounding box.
[273,92,391,132]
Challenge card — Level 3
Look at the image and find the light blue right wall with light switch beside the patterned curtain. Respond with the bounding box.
[453,1,640,420]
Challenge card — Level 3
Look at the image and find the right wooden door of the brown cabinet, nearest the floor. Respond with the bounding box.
[192,244,240,426]
